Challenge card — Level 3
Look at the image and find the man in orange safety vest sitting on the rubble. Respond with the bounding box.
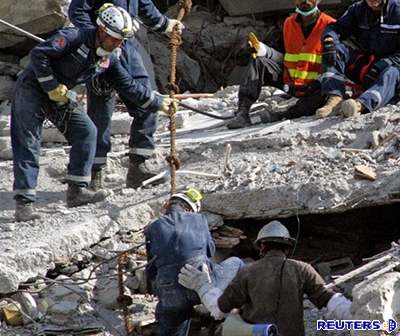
[227,0,334,129]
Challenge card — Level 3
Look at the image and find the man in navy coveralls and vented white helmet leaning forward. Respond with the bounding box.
[11,6,138,221]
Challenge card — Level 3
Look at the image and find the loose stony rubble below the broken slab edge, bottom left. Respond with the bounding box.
[0,232,156,335]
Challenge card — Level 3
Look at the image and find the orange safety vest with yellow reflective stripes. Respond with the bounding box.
[283,13,335,96]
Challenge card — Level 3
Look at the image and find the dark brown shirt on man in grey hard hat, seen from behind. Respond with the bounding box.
[218,251,334,336]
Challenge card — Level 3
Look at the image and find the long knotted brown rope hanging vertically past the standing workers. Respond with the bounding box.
[167,0,192,195]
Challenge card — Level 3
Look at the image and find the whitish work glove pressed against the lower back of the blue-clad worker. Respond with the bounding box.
[178,263,213,299]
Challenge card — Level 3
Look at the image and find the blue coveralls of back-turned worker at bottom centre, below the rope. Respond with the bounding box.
[145,205,216,336]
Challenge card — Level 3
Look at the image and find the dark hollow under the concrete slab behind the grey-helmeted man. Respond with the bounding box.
[220,203,400,274]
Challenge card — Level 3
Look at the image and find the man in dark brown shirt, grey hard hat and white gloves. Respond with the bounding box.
[179,221,351,336]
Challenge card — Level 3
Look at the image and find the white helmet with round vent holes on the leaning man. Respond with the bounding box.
[96,4,139,40]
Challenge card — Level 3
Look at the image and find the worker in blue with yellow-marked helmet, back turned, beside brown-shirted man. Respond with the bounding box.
[145,188,243,336]
